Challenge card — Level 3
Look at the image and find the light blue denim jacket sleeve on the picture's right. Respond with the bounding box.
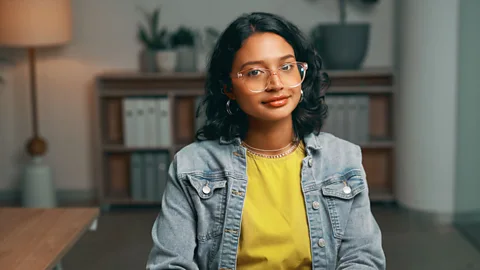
[337,147,386,270]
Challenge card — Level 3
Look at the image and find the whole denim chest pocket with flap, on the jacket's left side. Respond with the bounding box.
[187,175,227,242]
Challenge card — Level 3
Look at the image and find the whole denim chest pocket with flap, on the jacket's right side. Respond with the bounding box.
[321,170,367,239]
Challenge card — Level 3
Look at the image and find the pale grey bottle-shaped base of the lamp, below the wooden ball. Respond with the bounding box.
[22,156,57,208]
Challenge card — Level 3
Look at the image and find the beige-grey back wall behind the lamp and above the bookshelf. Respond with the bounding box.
[0,0,393,194]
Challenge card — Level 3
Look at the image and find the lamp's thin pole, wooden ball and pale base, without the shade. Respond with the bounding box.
[22,48,56,208]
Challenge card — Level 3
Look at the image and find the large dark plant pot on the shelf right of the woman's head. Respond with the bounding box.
[311,0,378,70]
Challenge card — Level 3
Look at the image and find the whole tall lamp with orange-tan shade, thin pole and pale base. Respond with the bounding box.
[0,0,72,207]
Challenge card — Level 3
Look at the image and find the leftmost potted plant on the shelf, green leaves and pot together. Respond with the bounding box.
[137,8,177,72]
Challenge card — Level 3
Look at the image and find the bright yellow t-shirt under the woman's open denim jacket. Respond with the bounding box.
[237,143,312,270]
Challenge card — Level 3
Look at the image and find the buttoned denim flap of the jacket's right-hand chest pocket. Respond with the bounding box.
[322,170,367,200]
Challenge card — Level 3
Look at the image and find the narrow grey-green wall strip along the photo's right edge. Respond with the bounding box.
[455,0,480,223]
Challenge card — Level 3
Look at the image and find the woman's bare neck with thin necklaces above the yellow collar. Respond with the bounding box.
[244,118,295,155]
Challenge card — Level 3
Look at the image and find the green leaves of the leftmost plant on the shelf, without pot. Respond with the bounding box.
[137,8,169,51]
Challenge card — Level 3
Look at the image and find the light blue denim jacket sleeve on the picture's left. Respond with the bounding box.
[146,156,198,270]
